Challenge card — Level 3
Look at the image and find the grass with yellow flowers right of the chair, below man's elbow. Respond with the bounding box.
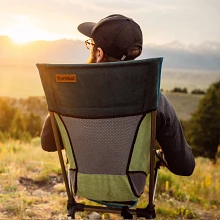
[155,157,220,219]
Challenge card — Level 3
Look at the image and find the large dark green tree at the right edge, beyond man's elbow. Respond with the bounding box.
[187,81,220,160]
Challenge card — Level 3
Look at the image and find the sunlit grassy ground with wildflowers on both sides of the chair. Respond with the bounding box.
[0,138,220,219]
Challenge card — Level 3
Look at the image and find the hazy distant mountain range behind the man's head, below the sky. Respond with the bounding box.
[0,36,220,71]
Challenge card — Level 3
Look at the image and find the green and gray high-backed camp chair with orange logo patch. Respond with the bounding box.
[37,58,163,219]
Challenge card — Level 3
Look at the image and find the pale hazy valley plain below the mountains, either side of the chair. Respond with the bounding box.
[0,64,220,98]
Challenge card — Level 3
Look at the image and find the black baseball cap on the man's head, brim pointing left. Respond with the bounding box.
[78,14,143,60]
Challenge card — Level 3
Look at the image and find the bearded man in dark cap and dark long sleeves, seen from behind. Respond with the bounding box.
[41,14,195,176]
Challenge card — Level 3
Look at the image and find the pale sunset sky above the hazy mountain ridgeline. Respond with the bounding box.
[0,0,220,45]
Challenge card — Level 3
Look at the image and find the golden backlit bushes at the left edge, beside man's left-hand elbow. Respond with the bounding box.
[0,98,42,142]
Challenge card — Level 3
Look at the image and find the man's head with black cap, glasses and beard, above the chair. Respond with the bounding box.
[78,14,143,62]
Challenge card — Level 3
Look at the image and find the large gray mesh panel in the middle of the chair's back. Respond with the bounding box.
[61,115,142,175]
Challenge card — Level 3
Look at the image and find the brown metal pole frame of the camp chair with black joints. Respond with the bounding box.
[49,110,160,220]
